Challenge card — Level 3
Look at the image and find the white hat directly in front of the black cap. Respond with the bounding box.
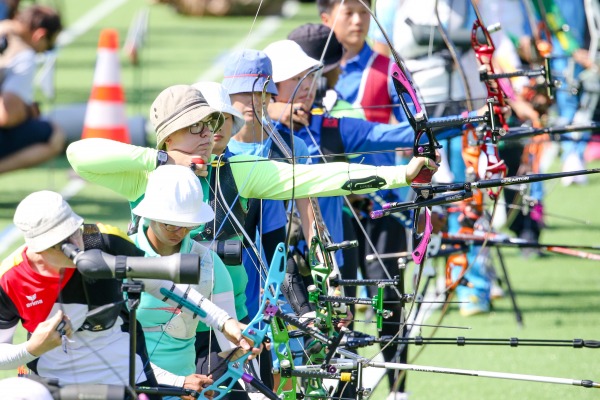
[264,40,320,83]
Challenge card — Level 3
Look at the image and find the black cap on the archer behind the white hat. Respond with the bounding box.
[288,24,344,72]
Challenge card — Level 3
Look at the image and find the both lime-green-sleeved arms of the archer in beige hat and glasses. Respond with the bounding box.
[67,139,436,201]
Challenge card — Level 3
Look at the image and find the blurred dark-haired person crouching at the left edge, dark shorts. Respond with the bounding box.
[0,5,65,173]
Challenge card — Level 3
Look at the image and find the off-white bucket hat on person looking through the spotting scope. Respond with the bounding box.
[13,190,83,253]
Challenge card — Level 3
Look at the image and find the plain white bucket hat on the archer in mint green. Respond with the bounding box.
[132,165,215,227]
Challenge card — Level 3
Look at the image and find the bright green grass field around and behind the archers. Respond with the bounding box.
[0,0,600,400]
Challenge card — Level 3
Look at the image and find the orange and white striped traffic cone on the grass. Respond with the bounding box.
[81,29,131,143]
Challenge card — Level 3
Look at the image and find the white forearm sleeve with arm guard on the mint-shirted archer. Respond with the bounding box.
[143,279,231,331]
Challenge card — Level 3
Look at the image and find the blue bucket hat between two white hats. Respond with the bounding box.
[223,50,277,96]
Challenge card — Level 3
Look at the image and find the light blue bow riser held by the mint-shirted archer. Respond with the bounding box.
[202,244,286,400]
